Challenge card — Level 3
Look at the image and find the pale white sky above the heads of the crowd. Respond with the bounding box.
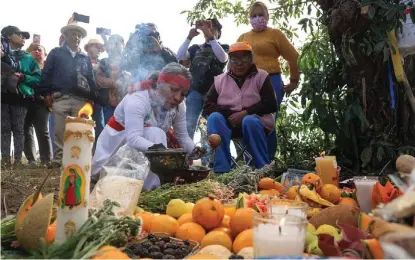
[0,0,254,55]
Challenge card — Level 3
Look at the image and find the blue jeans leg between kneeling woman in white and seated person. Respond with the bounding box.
[186,90,205,139]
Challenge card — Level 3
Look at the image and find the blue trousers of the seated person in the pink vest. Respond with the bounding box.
[207,112,270,173]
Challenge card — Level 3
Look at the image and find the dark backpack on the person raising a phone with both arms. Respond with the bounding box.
[190,45,224,94]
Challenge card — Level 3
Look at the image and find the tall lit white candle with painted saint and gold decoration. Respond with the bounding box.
[55,103,95,244]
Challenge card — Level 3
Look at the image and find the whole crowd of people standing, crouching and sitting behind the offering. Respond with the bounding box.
[1,2,300,189]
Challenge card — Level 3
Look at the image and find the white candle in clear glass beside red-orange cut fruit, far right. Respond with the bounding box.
[353,176,378,213]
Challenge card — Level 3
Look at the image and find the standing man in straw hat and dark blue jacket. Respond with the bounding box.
[39,18,96,168]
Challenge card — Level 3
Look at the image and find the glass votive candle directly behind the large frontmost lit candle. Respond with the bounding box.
[267,198,308,219]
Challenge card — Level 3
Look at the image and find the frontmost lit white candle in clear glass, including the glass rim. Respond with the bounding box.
[253,214,308,258]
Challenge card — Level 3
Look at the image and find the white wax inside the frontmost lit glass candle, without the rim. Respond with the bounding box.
[254,223,305,258]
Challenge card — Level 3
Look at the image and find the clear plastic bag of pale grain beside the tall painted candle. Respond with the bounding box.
[89,145,150,216]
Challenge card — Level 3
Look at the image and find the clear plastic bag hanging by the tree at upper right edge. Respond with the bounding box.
[398,1,415,58]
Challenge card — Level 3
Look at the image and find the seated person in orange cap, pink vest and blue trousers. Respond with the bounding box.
[203,42,277,173]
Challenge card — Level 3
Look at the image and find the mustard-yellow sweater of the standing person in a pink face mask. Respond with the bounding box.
[238,28,300,80]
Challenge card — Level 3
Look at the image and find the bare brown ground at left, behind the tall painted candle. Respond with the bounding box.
[0,168,60,218]
